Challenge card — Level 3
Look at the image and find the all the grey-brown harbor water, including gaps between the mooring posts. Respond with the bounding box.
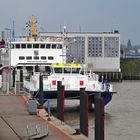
[51,81,140,140]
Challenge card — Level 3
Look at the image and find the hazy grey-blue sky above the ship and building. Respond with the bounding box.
[0,0,140,45]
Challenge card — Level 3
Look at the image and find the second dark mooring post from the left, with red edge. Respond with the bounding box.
[57,81,65,121]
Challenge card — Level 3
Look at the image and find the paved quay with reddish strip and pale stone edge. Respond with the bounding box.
[0,94,88,140]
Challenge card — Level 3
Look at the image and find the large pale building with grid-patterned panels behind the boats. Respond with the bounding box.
[40,31,120,72]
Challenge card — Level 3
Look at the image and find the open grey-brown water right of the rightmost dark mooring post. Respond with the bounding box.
[105,81,140,140]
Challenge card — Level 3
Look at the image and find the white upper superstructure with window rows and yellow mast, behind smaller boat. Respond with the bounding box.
[1,16,65,72]
